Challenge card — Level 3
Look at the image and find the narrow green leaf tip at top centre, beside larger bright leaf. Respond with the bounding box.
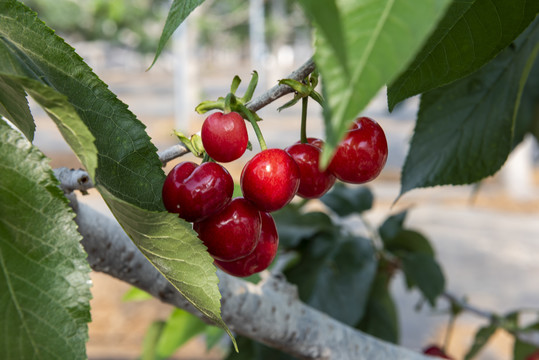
[299,0,349,74]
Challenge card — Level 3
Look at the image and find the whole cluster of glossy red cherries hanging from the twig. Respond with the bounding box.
[163,112,387,277]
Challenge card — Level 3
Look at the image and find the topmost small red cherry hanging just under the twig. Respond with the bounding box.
[200,112,249,163]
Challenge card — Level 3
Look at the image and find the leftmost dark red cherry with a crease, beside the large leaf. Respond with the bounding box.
[162,162,234,222]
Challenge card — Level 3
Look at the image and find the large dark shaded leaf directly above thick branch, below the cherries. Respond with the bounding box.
[286,234,377,325]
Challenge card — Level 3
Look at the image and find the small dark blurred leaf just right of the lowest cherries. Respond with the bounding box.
[272,206,335,248]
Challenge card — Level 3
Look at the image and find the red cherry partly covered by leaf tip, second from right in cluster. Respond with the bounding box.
[285,144,336,199]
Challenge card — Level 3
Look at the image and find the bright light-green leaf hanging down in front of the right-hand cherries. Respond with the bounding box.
[315,0,450,166]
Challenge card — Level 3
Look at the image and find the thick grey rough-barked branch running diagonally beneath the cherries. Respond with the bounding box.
[73,203,428,360]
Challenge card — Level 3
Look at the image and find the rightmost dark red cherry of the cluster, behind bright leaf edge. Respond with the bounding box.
[329,117,387,184]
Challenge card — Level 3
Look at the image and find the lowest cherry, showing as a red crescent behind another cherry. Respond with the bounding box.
[215,212,279,277]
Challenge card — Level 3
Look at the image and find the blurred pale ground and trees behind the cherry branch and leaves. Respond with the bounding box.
[23,0,539,360]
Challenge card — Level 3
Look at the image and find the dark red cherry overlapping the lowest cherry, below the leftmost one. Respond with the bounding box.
[193,197,262,261]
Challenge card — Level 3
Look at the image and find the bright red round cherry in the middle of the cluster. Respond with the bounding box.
[240,149,300,212]
